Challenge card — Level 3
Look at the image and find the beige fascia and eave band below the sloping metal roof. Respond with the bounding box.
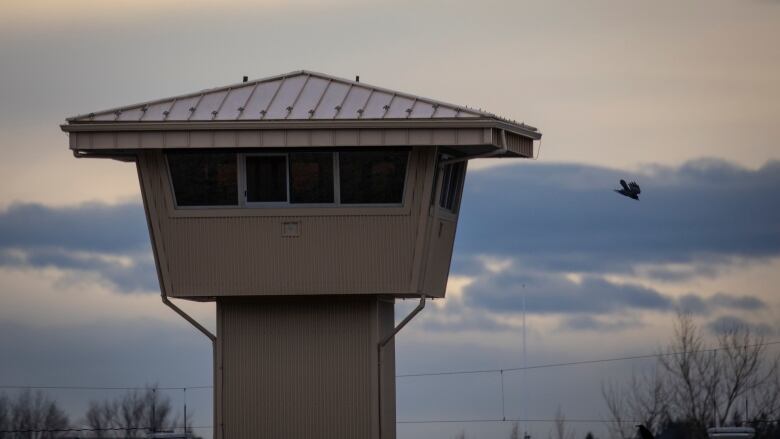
[62,118,541,158]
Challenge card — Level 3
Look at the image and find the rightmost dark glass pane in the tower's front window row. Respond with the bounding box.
[339,150,409,204]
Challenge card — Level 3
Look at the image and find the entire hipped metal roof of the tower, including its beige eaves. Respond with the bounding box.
[61,71,542,161]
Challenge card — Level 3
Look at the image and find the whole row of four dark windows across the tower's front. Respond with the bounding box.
[166,149,409,207]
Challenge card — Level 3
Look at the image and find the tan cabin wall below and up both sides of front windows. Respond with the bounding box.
[139,149,454,298]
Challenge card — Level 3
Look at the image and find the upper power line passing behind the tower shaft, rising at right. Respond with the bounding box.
[0,340,780,391]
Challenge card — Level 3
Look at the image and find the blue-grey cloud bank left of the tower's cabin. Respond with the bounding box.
[0,203,158,292]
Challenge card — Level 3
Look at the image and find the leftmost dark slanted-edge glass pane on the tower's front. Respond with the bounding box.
[167,152,238,206]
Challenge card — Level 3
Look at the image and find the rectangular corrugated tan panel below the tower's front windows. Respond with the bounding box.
[164,216,415,296]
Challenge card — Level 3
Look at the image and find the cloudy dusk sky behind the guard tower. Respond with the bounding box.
[0,0,780,439]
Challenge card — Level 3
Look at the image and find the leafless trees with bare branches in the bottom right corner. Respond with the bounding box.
[602,314,780,439]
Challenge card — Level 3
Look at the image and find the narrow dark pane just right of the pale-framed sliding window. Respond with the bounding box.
[290,152,333,203]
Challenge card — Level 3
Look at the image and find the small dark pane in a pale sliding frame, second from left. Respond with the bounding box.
[246,155,287,203]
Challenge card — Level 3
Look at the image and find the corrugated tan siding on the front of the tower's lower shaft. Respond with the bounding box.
[218,296,395,439]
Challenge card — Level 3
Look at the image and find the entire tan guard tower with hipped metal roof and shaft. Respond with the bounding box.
[62,71,541,439]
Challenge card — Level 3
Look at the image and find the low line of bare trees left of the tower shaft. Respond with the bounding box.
[0,387,197,439]
